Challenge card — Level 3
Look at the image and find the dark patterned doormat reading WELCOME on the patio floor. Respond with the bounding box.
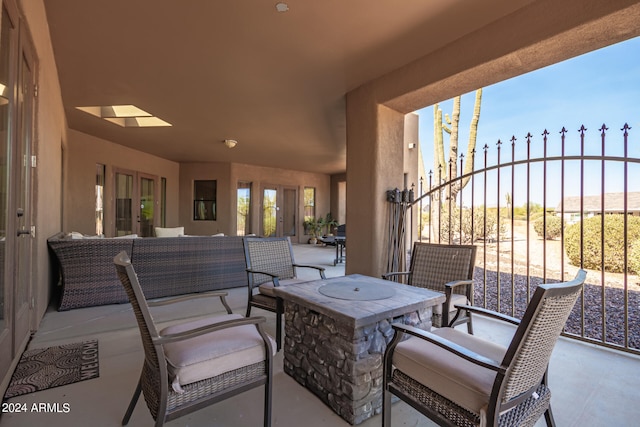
[4,340,100,399]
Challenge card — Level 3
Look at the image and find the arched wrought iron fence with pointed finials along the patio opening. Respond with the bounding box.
[408,124,640,354]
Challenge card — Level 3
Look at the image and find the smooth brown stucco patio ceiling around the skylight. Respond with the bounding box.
[45,0,531,173]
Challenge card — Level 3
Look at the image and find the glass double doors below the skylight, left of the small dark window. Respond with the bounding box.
[113,169,159,237]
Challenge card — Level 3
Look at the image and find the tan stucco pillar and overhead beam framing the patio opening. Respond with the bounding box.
[346,0,640,276]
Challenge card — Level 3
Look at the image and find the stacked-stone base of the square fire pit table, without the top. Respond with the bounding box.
[283,300,432,424]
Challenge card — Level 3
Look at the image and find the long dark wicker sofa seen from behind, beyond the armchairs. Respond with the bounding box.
[48,233,247,311]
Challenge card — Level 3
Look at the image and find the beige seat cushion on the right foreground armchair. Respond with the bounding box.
[393,328,507,414]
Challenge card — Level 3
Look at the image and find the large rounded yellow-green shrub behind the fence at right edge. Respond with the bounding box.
[565,214,640,273]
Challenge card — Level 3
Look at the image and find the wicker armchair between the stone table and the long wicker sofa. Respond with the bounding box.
[244,237,326,350]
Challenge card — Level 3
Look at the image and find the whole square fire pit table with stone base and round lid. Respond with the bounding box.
[274,274,444,424]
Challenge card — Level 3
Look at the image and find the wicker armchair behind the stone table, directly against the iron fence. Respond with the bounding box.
[382,242,476,334]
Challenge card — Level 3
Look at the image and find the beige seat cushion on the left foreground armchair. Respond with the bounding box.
[160,314,276,392]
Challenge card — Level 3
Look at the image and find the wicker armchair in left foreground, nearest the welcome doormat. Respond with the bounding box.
[114,251,274,427]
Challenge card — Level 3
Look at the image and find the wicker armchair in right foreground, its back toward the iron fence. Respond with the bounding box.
[382,270,586,427]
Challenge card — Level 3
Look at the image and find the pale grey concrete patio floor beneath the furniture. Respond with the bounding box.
[0,245,640,427]
